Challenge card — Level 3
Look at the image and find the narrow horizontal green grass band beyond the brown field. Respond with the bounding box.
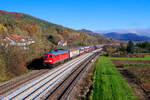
[109,55,150,60]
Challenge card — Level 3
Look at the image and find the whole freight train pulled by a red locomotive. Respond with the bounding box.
[43,45,102,66]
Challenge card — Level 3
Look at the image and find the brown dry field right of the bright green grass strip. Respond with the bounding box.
[112,58,150,100]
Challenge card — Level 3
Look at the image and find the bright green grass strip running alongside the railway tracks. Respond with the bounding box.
[90,57,137,100]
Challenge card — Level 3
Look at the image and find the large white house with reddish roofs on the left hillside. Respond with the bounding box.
[1,34,35,49]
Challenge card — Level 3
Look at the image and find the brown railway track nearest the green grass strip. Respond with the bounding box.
[44,53,97,100]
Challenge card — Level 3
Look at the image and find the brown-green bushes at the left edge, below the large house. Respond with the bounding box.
[0,46,27,81]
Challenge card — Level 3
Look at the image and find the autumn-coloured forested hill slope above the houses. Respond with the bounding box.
[0,10,109,48]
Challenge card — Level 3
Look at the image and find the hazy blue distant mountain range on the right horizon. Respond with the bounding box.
[104,32,150,42]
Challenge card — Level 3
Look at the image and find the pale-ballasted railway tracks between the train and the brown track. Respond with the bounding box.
[0,53,93,100]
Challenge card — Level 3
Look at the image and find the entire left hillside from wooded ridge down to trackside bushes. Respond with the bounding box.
[0,10,111,82]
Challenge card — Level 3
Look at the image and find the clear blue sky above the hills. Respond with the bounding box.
[0,0,150,31]
